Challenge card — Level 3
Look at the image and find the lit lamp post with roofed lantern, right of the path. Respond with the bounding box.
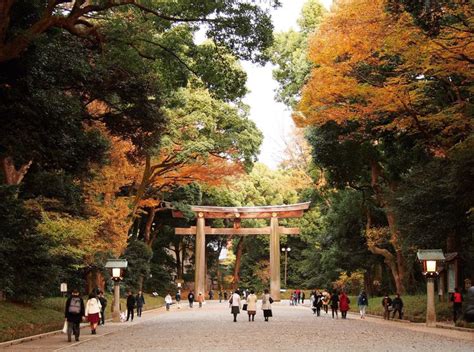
[417,249,445,326]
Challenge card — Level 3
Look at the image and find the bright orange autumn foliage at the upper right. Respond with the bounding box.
[293,0,474,147]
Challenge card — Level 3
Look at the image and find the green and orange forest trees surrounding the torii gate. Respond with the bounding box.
[0,0,474,301]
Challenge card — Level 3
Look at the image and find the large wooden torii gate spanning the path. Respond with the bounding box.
[172,202,310,301]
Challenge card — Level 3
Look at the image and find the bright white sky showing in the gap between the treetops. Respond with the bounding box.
[242,0,332,169]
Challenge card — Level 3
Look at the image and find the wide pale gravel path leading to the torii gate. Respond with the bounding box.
[1,301,474,352]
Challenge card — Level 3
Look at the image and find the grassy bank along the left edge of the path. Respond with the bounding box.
[0,295,164,342]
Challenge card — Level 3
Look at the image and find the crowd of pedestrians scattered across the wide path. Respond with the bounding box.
[64,288,474,341]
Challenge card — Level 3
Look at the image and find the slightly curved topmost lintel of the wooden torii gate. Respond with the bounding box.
[173,202,310,219]
